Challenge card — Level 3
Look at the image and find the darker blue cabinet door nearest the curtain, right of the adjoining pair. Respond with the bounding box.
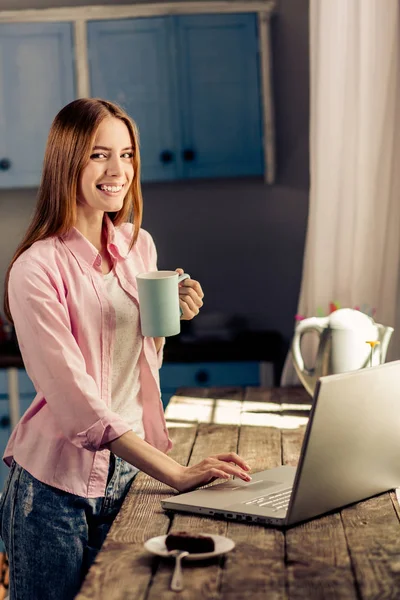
[176,14,263,177]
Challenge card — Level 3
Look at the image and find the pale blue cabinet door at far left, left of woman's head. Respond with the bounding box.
[0,23,75,188]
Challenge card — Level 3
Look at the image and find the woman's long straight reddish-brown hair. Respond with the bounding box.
[4,98,143,322]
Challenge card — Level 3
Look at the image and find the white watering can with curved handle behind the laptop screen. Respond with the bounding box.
[292,308,393,396]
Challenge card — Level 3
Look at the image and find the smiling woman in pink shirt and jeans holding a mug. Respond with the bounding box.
[0,99,250,600]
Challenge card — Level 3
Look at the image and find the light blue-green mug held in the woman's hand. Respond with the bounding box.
[136,271,190,337]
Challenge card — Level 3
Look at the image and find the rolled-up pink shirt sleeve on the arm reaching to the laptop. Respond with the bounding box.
[8,261,130,451]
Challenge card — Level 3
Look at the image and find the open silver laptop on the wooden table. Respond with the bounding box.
[161,360,400,527]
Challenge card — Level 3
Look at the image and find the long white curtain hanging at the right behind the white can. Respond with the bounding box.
[282,0,400,385]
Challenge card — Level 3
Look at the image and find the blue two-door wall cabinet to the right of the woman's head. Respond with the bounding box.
[88,14,263,181]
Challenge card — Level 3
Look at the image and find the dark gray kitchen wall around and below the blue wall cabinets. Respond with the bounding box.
[0,0,309,339]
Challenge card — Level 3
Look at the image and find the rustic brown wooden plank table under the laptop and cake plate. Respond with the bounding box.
[77,388,400,600]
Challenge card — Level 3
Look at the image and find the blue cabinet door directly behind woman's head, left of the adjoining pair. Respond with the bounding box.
[88,17,180,181]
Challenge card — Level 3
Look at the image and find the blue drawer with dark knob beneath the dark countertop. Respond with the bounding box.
[160,361,260,389]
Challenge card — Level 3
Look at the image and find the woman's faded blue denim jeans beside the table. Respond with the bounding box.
[0,454,138,600]
